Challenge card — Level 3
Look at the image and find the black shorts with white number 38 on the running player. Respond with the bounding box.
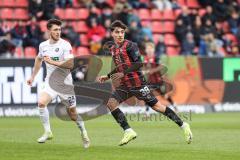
[111,85,158,107]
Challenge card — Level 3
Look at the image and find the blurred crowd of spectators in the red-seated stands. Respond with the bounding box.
[0,0,240,57]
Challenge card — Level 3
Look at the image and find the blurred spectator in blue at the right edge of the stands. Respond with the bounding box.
[228,11,240,35]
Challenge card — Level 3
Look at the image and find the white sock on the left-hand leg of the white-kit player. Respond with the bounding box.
[38,107,51,132]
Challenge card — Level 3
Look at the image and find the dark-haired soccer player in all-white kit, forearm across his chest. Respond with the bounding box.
[27,19,90,148]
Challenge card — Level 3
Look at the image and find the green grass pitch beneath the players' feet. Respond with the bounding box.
[0,113,240,160]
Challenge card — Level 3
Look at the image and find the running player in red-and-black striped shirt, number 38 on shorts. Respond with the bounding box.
[98,20,192,146]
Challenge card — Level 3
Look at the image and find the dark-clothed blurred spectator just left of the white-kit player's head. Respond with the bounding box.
[23,17,43,48]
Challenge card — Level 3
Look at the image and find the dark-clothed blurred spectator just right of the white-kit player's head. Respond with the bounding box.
[62,22,80,47]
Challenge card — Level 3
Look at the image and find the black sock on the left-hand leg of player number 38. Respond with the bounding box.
[111,108,130,130]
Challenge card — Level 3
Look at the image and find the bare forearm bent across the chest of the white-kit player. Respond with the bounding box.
[43,56,74,69]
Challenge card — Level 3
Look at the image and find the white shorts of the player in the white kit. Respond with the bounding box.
[41,83,76,108]
